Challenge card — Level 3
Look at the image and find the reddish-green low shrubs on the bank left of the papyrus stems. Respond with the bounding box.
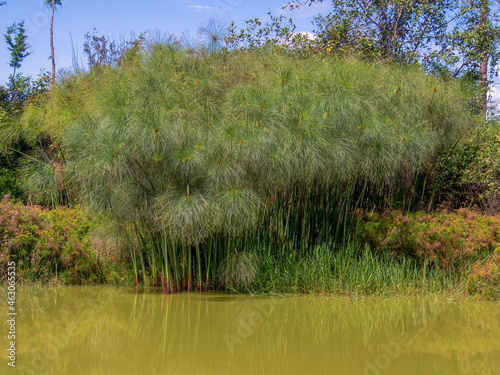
[0,198,105,284]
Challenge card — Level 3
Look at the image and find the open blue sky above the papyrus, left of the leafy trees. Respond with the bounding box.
[0,0,330,80]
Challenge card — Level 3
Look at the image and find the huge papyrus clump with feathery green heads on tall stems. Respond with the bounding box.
[16,40,470,291]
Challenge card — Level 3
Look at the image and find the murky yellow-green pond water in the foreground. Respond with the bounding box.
[0,287,500,375]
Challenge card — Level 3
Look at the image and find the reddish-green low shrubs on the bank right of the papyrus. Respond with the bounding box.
[358,209,500,269]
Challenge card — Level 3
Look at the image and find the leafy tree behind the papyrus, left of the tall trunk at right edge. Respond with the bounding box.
[285,0,455,63]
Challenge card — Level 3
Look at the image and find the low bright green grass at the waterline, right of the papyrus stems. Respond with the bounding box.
[247,242,466,297]
